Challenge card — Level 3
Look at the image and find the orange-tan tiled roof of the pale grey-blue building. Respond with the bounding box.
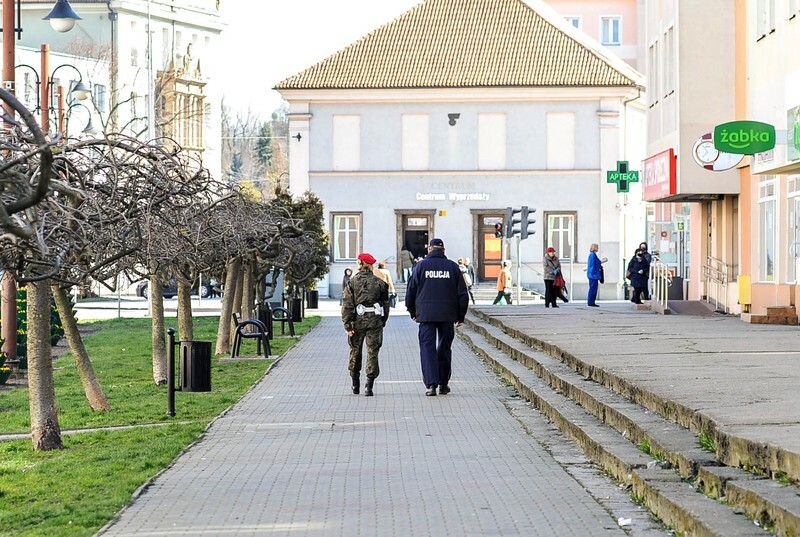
[276,0,641,90]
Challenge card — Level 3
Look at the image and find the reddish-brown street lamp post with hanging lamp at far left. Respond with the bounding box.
[0,0,80,360]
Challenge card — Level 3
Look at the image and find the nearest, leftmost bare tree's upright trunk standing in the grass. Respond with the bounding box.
[27,282,64,451]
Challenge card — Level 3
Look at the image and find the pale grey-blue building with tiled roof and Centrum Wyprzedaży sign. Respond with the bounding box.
[276,0,644,298]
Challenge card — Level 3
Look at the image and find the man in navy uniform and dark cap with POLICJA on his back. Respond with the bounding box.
[406,239,469,395]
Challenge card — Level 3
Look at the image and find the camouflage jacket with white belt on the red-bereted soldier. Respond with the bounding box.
[342,267,389,331]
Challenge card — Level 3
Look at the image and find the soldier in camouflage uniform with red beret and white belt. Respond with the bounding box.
[342,252,389,397]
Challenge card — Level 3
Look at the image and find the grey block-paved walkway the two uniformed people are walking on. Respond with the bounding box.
[101,301,625,537]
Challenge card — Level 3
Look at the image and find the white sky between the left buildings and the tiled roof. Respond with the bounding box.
[218,0,421,119]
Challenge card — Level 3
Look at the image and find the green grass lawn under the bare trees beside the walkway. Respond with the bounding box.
[0,317,319,537]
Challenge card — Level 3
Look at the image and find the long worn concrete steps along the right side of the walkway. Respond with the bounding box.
[460,310,800,536]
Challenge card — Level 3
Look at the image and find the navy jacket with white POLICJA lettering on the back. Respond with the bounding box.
[406,249,469,323]
